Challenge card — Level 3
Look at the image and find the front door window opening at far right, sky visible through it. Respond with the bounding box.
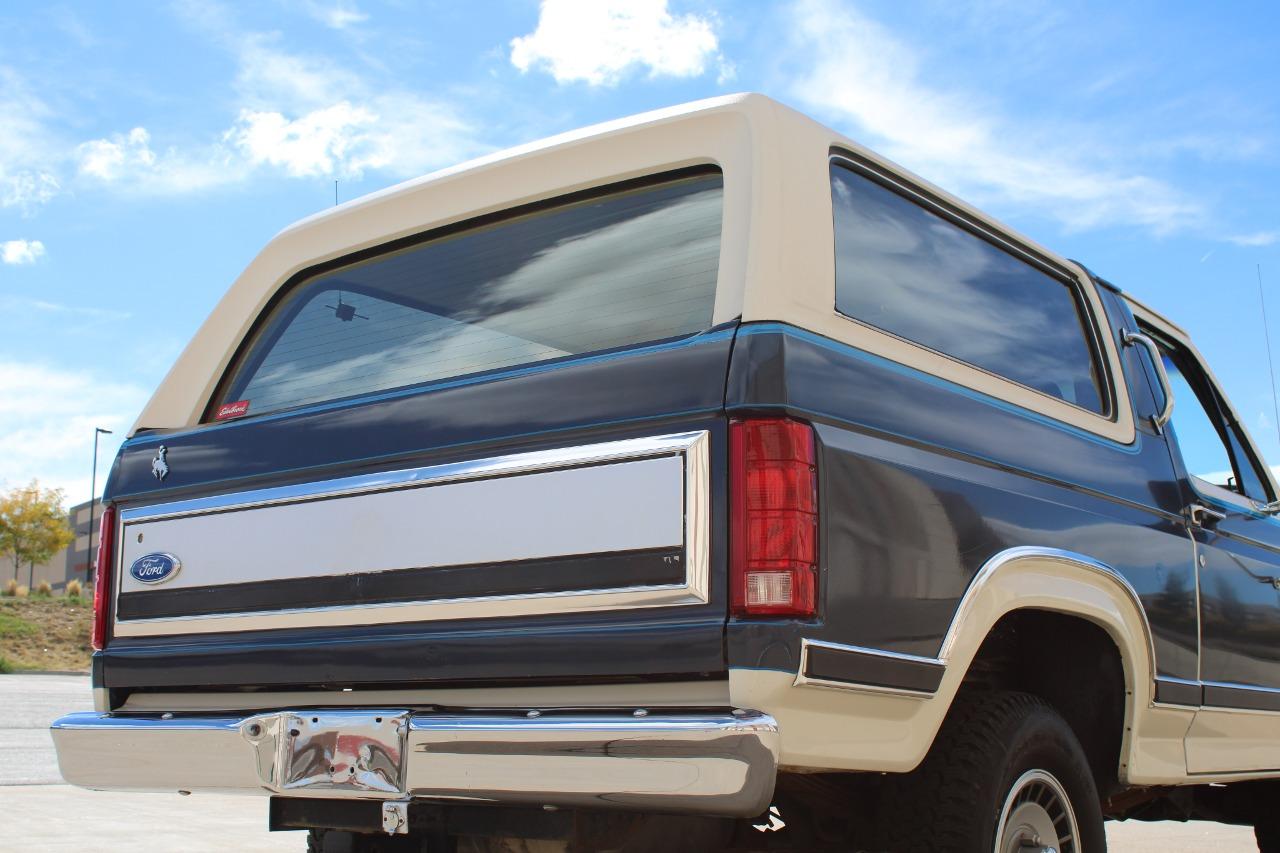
[1153,334,1271,503]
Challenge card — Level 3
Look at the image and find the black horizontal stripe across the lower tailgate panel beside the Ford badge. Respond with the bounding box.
[116,548,685,620]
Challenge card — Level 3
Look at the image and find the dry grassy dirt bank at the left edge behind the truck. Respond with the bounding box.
[0,597,93,672]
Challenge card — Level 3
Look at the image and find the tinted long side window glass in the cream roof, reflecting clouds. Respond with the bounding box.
[831,163,1105,412]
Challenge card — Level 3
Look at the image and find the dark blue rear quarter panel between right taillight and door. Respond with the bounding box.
[726,311,1197,679]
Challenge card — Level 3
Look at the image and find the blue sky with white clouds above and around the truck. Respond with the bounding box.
[0,0,1280,503]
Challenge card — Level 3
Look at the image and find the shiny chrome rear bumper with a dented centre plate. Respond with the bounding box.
[52,708,778,817]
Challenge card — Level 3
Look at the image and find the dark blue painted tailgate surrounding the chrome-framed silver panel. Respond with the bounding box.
[93,328,733,690]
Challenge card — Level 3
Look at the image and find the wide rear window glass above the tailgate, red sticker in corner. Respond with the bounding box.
[215,167,723,418]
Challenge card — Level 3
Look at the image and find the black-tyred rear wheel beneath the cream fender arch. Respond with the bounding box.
[878,690,1107,853]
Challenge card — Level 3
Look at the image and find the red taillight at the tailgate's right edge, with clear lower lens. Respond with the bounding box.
[728,418,818,617]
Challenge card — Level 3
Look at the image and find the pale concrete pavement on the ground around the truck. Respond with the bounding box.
[0,675,1257,853]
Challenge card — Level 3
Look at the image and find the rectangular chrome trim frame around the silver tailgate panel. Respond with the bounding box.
[113,430,710,637]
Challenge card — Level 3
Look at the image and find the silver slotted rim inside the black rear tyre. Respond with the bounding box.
[995,770,1080,853]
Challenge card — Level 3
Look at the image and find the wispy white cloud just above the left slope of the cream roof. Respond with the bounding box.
[62,20,481,193]
